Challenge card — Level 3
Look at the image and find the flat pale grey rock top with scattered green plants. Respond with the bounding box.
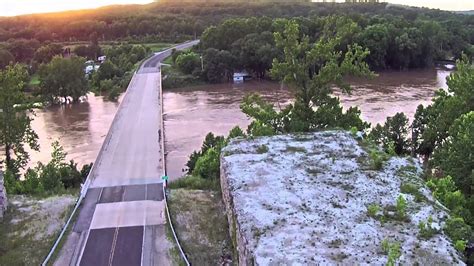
[221,131,463,265]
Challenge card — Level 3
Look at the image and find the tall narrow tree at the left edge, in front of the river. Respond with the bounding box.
[0,64,39,174]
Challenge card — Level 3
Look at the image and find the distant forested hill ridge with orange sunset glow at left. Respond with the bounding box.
[0,1,474,46]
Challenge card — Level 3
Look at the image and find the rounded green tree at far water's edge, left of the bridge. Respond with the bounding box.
[39,56,88,103]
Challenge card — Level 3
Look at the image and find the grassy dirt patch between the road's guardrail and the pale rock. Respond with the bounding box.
[169,189,232,265]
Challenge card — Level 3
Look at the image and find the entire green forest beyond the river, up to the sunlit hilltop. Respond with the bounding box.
[0,1,474,90]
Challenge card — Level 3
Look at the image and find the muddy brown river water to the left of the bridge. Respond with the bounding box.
[26,94,119,168]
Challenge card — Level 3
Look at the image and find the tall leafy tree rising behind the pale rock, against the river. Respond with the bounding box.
[241,17,372,135]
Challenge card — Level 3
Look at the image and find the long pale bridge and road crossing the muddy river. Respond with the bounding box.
[54,41,198,266]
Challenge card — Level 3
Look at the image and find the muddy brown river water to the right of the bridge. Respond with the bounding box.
[163,69,449,178]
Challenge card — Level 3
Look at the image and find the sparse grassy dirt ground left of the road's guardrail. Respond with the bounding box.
[0,195,76,265]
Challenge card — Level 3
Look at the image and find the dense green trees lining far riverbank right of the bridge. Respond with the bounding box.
[195,15,474,82]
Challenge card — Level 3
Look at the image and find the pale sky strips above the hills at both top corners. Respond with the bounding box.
[0,0,474,16]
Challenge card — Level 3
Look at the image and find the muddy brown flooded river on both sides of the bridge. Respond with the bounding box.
[25,70,449,179]
